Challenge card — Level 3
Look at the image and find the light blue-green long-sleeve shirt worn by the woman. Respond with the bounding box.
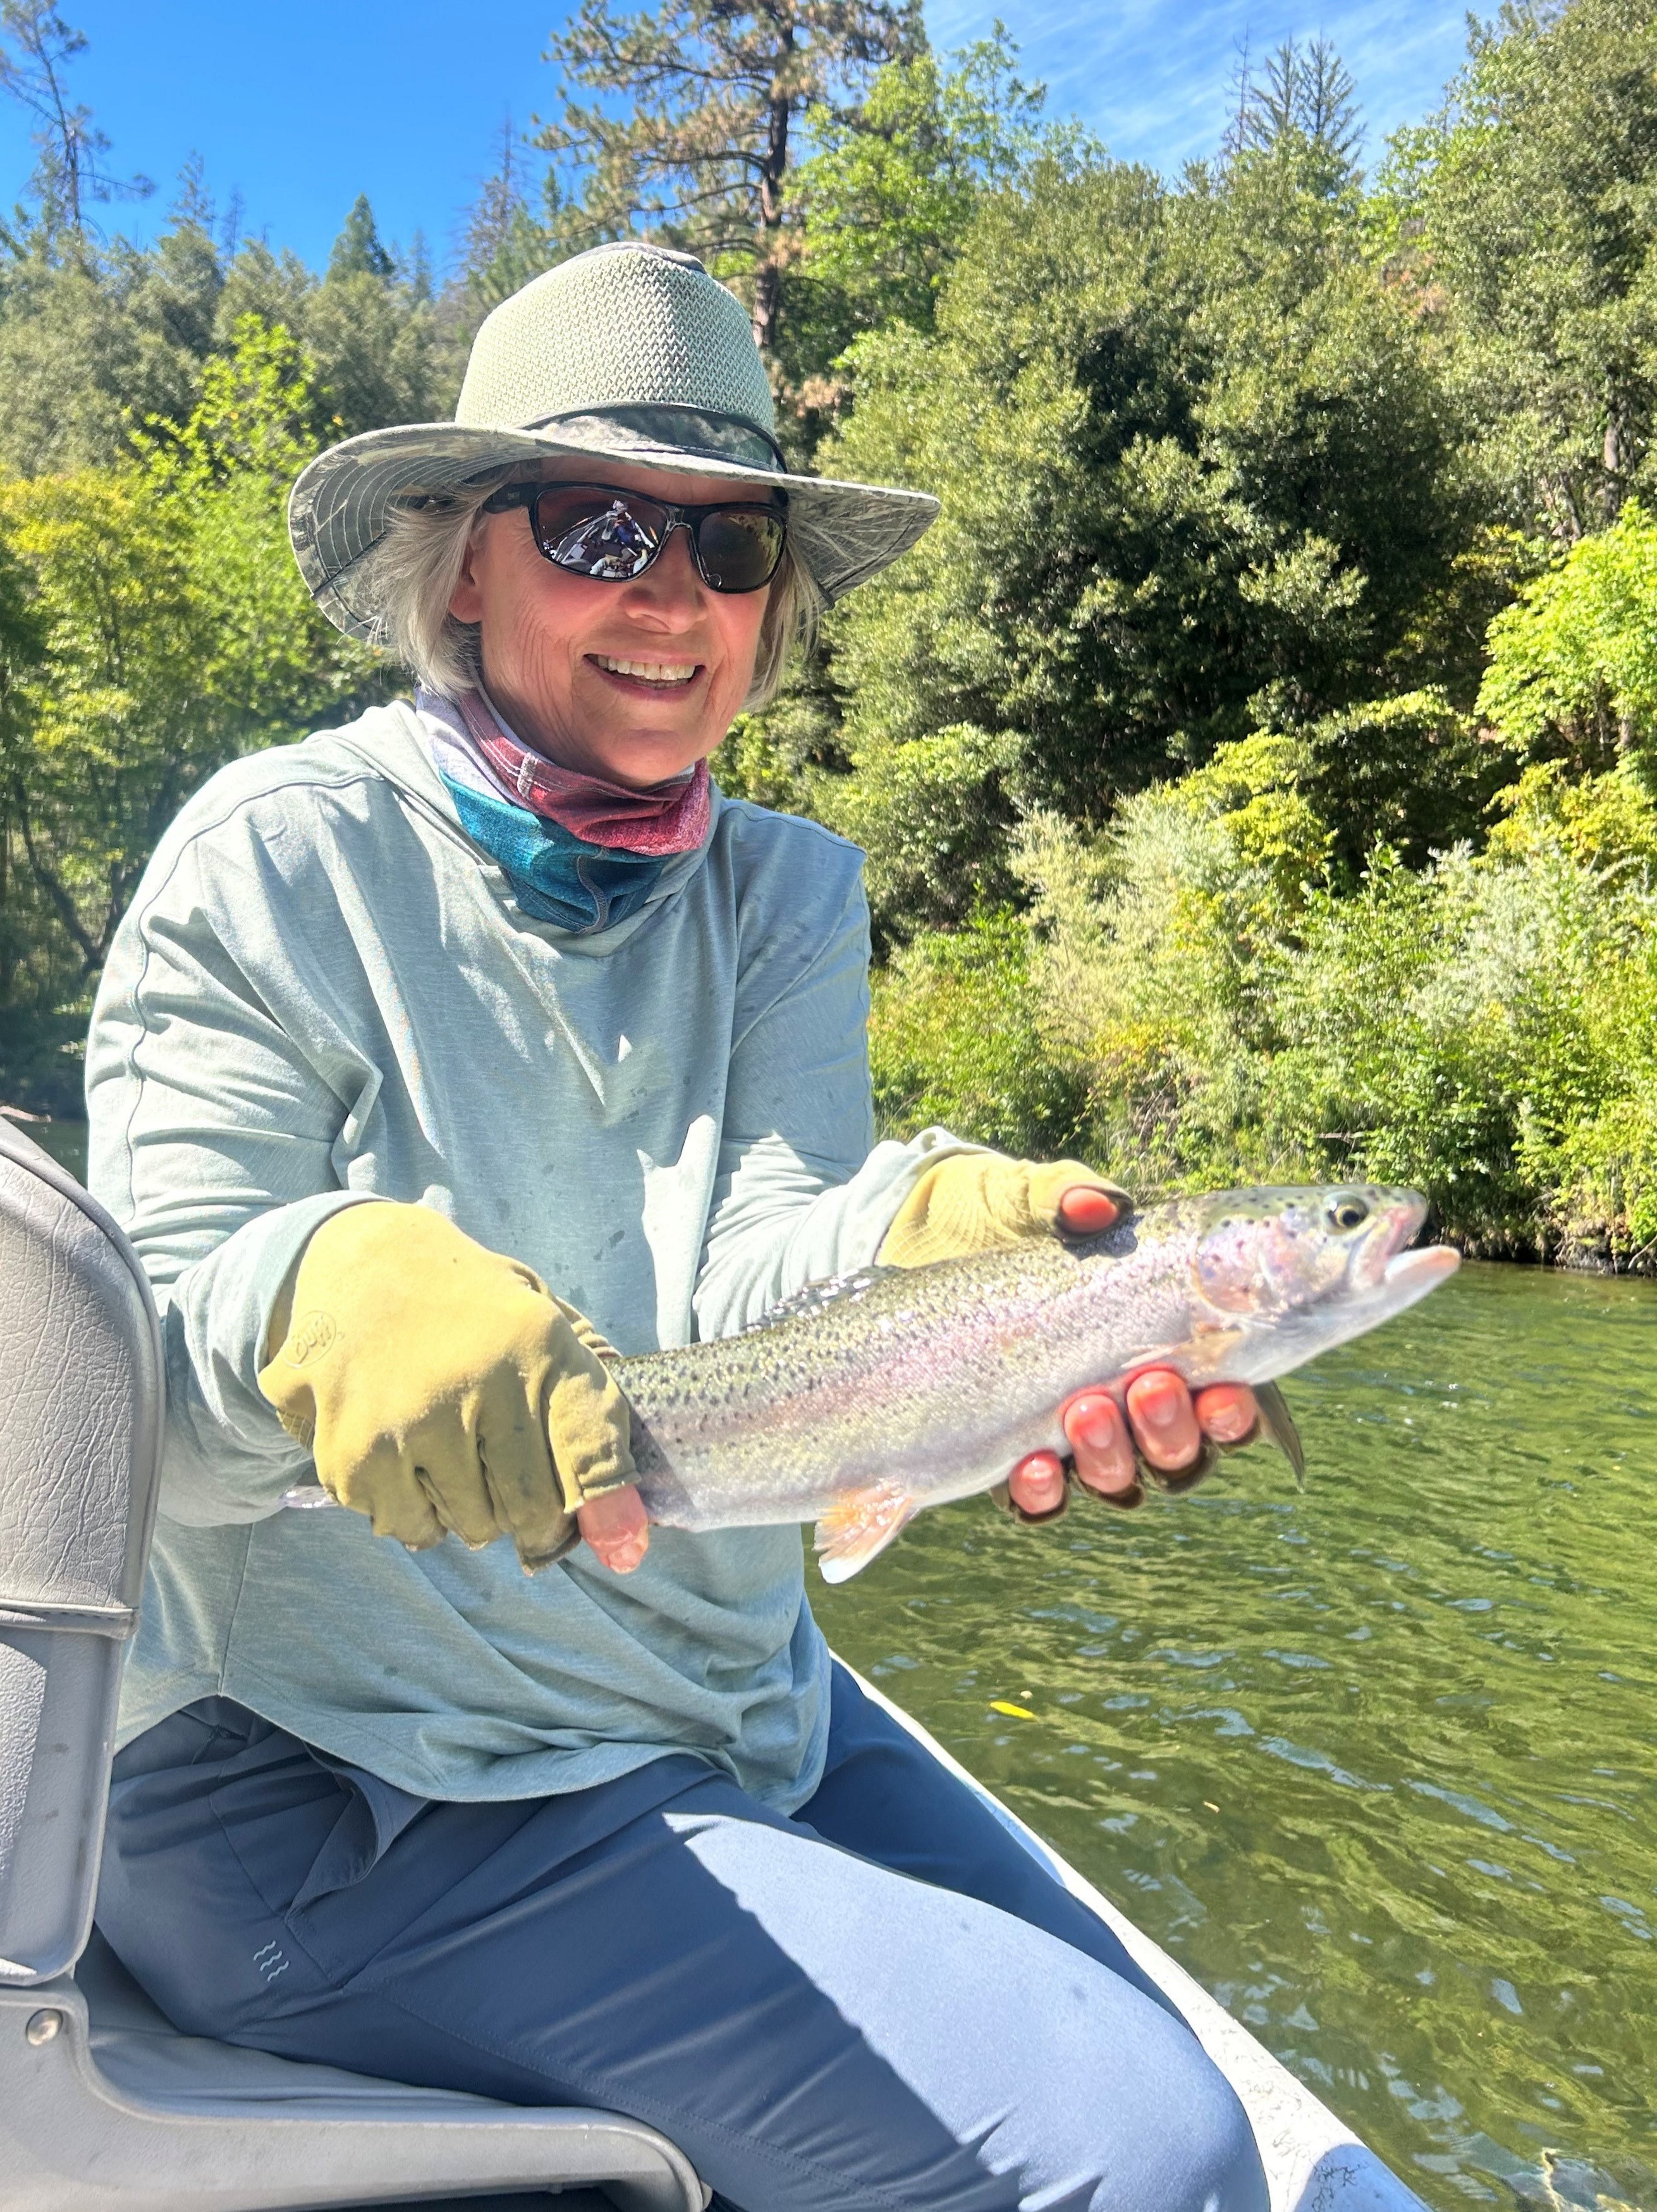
[86,703,969,1809]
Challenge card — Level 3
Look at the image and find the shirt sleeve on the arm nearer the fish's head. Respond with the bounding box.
[692,883,982,1341]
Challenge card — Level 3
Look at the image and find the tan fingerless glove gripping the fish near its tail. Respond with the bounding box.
[259,1201,633,1571]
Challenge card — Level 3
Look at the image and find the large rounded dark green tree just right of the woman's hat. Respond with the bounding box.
[814,142,1469,933]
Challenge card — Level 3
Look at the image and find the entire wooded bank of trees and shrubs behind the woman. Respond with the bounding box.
[0,0,1657,1267]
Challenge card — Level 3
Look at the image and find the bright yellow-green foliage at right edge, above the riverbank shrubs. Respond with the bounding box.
[1478,500,1657,785]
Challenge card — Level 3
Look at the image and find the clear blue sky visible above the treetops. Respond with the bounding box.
[0,0,1465,266]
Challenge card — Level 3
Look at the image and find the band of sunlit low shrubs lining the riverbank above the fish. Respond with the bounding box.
[874,756,1657,1265]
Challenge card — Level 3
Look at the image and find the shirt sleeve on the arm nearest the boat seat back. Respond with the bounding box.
[86,814,378,1527]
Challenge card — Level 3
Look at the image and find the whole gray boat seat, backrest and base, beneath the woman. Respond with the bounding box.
[0,1119,708,2212]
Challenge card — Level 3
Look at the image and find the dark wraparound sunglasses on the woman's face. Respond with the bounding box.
[482,482,788,591]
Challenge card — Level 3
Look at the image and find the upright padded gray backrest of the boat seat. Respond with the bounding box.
[0,1117,161,1986]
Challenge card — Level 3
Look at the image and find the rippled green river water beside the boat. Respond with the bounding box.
[812,1265,1657,2212]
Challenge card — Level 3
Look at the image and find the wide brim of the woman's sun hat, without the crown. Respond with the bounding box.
[288,422,938,644]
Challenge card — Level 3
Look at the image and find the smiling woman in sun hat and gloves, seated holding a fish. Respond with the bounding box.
[89,245,1266,2212]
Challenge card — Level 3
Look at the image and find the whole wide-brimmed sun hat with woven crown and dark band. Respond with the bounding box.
[288,243,938,639]
